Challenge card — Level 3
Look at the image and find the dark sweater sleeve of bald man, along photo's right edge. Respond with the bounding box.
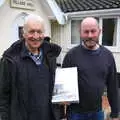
[107,57,119,118]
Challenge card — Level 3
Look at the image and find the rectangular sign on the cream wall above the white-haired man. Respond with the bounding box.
[10,0,35,10]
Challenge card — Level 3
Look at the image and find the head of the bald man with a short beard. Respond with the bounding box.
[80,17,101,50]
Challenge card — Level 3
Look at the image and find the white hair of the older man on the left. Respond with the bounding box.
[23,14,44,33]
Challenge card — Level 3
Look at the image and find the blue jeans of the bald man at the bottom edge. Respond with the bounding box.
[67,111,104,120]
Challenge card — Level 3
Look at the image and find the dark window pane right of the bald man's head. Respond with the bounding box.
[102,18,117,46]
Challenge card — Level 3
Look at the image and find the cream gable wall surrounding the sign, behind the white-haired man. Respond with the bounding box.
[0,0,51,56]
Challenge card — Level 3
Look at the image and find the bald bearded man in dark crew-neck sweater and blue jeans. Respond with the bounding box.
[63,17,118,120]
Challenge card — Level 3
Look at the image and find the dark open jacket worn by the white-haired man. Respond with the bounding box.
[0,40,61,120]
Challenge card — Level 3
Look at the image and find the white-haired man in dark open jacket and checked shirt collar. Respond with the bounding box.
[0,15,61,120]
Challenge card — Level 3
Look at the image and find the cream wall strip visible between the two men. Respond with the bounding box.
[51,21,70,64]
